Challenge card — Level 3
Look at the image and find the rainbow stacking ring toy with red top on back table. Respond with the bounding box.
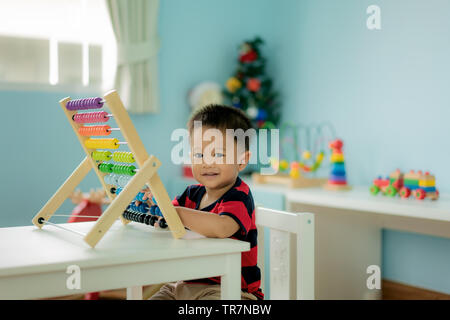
[324,139,351,191]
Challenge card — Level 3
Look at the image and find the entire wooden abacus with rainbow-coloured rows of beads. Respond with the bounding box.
[32,90,186,247]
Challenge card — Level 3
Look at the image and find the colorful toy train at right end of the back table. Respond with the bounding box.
[370,169,439,200]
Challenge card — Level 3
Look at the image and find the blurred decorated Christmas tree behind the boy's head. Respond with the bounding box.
[224,37,280,128]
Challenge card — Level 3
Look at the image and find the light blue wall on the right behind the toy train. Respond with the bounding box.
[277,0,450,293]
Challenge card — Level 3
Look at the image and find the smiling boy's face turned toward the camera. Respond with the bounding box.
[190,127,250,189]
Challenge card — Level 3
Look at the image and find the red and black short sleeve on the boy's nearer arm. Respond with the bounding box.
[218,192,254,236]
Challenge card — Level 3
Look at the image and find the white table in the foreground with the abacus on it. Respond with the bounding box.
[0,221,250,300]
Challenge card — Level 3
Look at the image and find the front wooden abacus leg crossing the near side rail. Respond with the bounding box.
[84,156,161,247]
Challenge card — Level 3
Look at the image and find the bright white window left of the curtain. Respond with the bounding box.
[0,0,116,89]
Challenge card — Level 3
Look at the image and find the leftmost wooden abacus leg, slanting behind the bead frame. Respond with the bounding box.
[31,157,92,228]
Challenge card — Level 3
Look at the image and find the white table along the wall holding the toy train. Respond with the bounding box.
[251,184,450,299]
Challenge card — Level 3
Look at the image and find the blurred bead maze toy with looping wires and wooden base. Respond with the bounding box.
[252,123,335,188]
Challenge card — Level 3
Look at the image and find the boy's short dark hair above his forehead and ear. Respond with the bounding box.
[187,104,253,151]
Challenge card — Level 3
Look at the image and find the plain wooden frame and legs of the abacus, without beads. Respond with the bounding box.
[32,90,186,248]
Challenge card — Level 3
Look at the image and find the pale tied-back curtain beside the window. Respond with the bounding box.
[106,0,159,113]
